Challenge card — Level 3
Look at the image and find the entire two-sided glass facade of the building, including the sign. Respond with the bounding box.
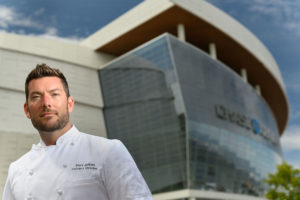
[99,34,281,196]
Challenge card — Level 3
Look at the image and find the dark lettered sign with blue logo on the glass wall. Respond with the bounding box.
[215,105,276,145]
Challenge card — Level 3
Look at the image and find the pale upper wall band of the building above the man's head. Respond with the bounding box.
[0,32,114,69]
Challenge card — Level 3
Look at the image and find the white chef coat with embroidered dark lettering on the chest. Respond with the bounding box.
[3,126,153,200]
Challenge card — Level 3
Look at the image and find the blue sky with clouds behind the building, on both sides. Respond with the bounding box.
[0,0,300,168]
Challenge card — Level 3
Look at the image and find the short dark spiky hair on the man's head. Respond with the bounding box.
[25,63,70,101]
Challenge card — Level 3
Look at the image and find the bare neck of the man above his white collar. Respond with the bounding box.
[39,123,72,146]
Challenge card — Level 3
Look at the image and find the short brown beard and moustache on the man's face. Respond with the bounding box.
[31,108,69,132]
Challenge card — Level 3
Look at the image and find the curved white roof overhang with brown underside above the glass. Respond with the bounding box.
[81,0,289,134]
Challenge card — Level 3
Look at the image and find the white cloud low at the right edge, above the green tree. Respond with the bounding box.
[281,124,300,152]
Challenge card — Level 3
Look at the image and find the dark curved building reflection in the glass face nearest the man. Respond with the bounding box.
[100,55,187,192]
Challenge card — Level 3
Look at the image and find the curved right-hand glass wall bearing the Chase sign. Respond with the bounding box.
[170,35,281,196]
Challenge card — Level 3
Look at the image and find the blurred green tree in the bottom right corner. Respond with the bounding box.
[265,162,300,200]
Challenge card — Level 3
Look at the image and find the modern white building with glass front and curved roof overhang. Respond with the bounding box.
[0,0,289,200]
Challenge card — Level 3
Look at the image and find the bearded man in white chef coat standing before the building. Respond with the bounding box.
[3,64,152,200]
